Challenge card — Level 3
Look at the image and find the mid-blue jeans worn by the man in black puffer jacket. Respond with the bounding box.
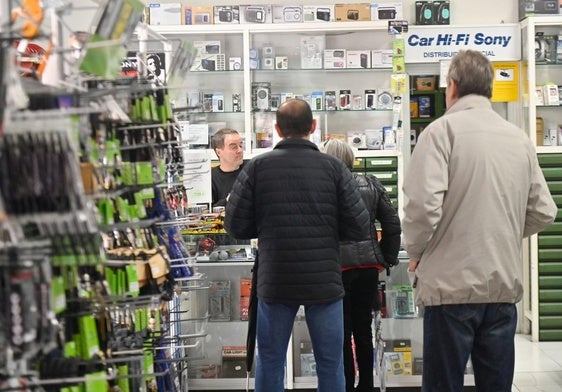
[255,300,345,392]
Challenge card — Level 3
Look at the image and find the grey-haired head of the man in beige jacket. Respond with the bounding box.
[447,50,494,98]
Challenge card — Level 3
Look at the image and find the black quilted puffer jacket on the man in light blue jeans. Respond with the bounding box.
[224,139,369,305]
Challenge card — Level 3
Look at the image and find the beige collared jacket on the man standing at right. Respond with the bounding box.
[402,95,557,305]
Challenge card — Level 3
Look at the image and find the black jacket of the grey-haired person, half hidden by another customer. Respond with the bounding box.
[340,173,402,271]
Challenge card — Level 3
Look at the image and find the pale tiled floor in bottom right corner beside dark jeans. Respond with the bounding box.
[512,335,562,392]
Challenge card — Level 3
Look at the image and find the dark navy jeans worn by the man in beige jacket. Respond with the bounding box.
[422,303,517,392]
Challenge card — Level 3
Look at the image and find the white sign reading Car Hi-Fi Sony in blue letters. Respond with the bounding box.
[405,23,521,64]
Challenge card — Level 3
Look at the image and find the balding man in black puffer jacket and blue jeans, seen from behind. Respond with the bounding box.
[225,99,369,392]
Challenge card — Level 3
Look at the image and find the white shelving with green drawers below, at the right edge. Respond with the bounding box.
[520,15,562,341]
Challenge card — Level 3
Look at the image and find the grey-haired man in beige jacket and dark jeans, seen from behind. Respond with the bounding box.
[402,50,557,392]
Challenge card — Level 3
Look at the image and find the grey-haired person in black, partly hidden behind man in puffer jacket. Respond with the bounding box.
[321,139,402,392]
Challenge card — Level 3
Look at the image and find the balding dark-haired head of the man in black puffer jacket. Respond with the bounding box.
[276,98,313,138]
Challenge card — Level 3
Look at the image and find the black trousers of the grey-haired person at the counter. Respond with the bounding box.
[342,268,379,392]
